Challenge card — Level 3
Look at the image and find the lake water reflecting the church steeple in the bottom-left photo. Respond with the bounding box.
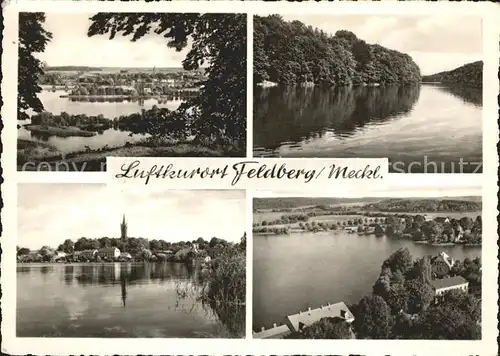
[17,263,244,338]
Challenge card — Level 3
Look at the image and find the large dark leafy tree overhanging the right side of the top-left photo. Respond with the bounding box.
[88,13,246,150]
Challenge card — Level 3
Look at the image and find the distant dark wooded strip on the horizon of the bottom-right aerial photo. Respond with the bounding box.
[364,199,481,213]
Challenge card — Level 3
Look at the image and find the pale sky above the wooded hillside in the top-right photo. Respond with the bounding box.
[283,14,482,75]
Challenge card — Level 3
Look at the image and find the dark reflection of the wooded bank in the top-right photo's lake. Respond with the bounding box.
[254,85,420,149]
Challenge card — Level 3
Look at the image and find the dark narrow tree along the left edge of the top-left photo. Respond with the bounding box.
[17,12,52,120]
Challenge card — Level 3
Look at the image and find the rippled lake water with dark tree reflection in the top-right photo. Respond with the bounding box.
[253,84,482,173]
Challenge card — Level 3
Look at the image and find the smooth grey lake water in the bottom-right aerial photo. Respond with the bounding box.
[253,232,481,330]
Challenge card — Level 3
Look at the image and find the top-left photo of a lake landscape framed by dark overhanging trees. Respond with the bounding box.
[17,12,247,171]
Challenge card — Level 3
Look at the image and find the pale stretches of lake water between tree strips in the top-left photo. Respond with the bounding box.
[18,90,183,153]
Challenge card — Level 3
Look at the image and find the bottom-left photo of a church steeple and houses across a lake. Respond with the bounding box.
[15,183,246,338]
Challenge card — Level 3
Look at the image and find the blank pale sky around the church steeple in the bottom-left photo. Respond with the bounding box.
[17,183,246,249]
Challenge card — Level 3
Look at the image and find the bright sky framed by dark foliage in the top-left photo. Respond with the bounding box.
[37,13,190,68]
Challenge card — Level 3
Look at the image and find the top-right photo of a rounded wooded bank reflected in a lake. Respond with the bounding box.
[253,13,483,173]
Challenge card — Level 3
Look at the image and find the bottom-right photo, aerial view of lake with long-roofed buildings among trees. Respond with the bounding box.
[252,195,482,340]
